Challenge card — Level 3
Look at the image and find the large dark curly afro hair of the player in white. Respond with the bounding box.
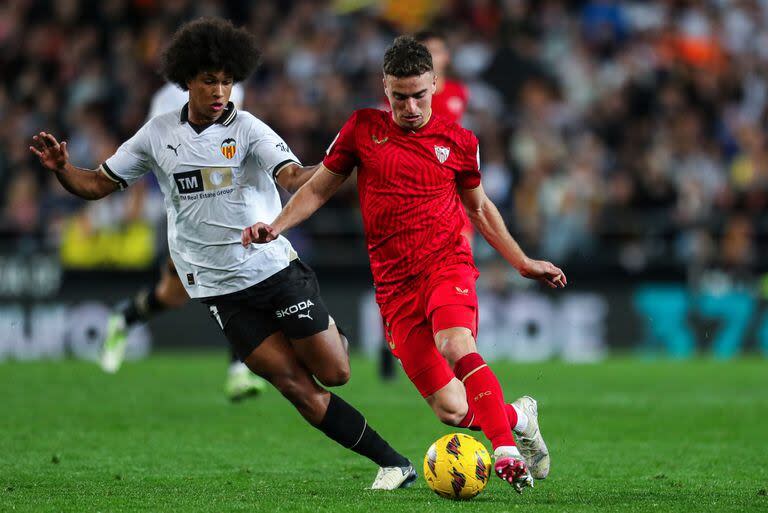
[160,18,261,91]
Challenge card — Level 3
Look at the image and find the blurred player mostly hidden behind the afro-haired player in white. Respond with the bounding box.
[100,82,267,402]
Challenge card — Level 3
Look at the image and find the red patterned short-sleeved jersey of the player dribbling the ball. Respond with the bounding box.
[323,109,480,304]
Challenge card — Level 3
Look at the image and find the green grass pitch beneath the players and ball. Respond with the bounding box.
[0,353,768,513]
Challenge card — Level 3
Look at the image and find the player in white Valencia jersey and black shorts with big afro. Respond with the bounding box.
[30,18,416,490]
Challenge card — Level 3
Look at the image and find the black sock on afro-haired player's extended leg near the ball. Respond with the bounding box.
[317,394,410,467]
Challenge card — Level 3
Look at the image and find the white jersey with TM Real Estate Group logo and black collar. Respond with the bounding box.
[101,102,299,298]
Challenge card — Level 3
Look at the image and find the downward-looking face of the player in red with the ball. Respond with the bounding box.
[384,71,435,129]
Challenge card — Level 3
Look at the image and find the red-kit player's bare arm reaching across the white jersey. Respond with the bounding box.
[242,164,347,246]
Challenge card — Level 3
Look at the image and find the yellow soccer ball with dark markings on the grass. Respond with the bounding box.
[424,433,491,499]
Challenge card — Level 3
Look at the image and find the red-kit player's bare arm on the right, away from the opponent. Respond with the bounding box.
[461,185,568,289]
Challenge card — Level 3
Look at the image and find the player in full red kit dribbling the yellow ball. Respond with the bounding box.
[242,36,566,492]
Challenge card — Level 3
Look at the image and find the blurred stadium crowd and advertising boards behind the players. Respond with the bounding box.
[0,0,768,361]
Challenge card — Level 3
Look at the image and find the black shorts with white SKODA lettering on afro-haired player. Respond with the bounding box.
[203,259,330,360]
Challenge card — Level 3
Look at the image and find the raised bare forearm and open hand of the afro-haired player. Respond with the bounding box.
[29,132,118,200]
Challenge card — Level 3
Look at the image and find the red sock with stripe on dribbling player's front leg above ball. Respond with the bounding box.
[453,353,515,449]
